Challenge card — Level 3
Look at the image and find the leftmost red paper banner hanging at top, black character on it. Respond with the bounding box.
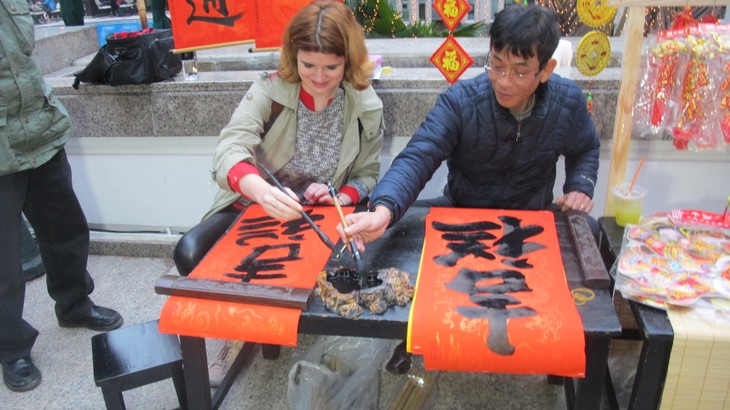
[169,0,258,49]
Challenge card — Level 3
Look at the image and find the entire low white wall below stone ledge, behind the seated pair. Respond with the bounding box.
[67,137,730,233]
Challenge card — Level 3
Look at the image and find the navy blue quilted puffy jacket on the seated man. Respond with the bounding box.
[370,74,600,223]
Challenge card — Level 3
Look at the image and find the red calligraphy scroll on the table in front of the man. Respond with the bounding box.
[408,208,585,377]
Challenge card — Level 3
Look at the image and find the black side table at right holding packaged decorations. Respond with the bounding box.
[598,217,674,410]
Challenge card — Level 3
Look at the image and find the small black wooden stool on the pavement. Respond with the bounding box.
[91,320,187,410]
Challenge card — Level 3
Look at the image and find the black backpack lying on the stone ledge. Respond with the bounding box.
[73,29,182,89]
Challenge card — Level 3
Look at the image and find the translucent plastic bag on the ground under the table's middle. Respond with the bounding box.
[287,336,395,410]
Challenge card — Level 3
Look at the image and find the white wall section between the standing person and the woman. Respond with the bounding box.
[66,137,217,232]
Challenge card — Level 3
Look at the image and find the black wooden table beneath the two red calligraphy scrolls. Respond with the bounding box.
[165,208,621,410]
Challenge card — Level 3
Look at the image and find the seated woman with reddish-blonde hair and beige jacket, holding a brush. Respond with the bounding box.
[174,0,384,384]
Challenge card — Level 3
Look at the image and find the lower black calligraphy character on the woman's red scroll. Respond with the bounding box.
[224,243,301,283]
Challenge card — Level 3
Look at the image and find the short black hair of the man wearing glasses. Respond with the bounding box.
[489,4,562,68]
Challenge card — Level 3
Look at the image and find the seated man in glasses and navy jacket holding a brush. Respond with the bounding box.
[338,5,600,372]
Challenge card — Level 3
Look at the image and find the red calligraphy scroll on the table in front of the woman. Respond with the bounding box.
[159,205,339,346]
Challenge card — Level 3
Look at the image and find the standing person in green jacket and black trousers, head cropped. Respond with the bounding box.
[0,0,124,391]
